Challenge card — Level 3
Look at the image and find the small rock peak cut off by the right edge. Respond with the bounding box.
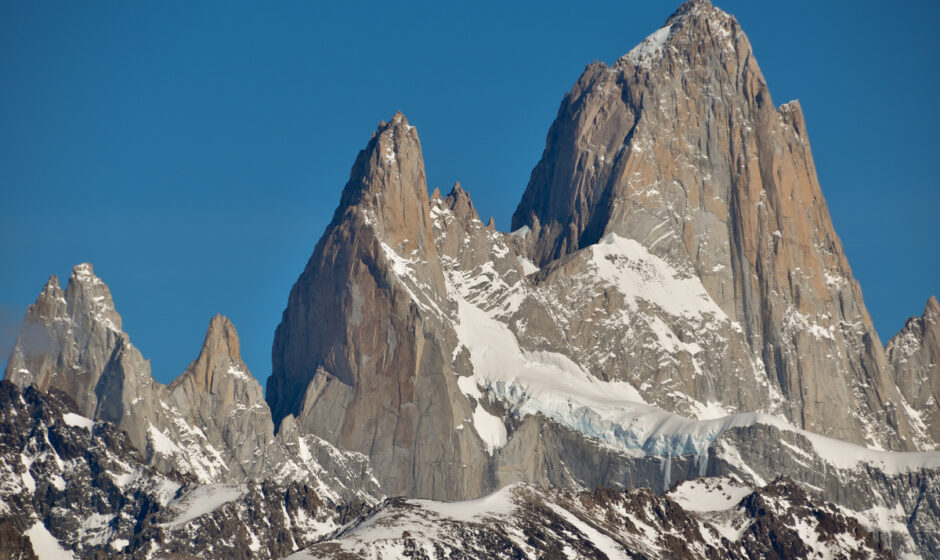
[885,296,940,445]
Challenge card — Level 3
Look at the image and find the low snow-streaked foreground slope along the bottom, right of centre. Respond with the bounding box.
[289,479,893,560]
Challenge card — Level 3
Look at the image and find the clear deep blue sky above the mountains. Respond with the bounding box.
[0,0,940,382]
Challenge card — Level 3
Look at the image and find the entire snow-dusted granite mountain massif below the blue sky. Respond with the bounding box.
[0,0,940,558]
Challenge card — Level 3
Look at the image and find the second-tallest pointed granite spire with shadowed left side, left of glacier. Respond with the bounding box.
[267,113,487,499]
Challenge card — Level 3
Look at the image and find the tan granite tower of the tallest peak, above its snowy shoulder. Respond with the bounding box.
[512,0,928,449]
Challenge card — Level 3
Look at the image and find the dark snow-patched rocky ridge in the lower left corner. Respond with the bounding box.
[0,380,371,559]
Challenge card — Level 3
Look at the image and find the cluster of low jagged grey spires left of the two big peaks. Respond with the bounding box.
[5,264,381,501]
